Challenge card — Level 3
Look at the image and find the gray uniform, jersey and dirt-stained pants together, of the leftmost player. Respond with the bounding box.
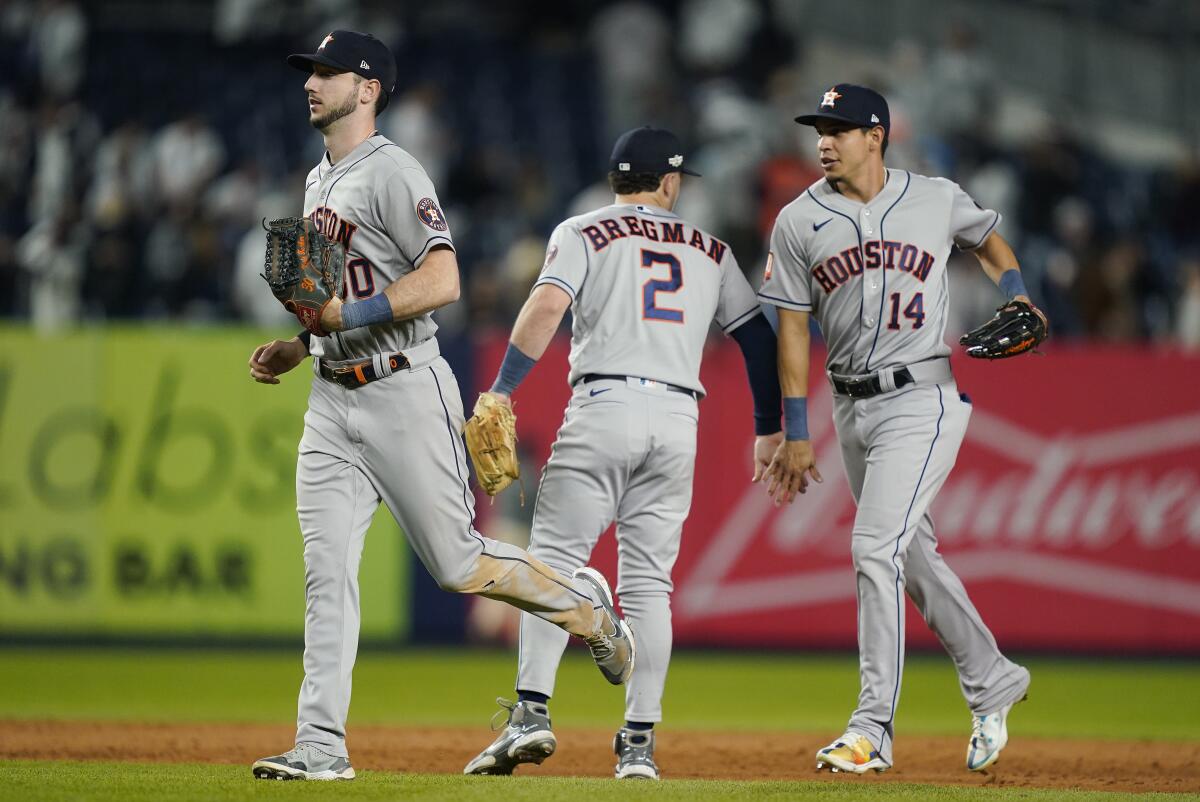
[286,134,614,756]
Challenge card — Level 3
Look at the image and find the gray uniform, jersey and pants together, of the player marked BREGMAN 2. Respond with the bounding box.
[517,205,761,722]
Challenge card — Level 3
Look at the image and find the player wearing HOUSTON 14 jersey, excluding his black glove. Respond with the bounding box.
[758,84,1044,773]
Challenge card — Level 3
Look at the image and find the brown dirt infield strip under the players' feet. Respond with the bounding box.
[0,720,1200,792]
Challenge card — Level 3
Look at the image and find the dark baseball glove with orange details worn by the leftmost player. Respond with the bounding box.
[262,217,346,337]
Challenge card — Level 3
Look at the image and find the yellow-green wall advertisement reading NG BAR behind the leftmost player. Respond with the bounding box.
[0,328,409,640]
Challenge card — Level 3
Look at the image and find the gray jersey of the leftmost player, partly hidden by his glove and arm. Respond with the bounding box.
[304,133,454,359]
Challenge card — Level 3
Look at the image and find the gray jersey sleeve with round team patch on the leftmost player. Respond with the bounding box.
[376,167,454,265]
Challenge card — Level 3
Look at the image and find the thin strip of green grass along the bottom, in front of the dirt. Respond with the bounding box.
[0,761,1183,802]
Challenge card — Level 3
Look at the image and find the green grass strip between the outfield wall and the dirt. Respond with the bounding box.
[0,648,1200,741]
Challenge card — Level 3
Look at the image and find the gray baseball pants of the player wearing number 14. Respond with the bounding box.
[834,379,1030,764]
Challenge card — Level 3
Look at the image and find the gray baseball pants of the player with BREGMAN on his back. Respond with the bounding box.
[516,378,698,722]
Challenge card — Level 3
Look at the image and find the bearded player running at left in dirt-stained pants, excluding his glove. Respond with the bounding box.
[250,30,634,779]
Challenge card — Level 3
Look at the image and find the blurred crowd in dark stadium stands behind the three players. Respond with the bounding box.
[0,0,1200,348]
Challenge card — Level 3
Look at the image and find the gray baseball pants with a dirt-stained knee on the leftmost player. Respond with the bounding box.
[296,339,598,756]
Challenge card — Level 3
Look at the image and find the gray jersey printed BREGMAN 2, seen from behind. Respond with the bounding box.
[538,205,758,394]
